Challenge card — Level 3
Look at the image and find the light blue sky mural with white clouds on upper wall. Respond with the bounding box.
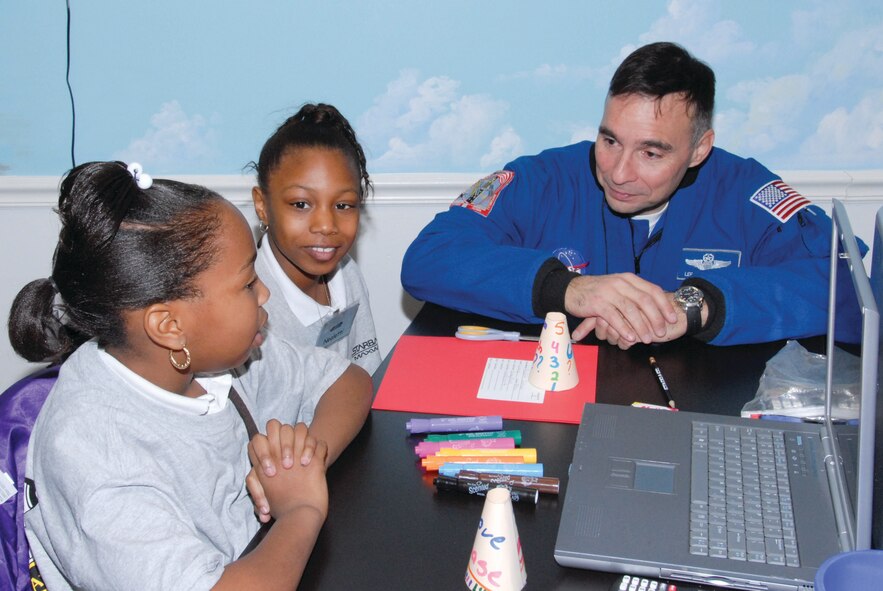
[0,0,883,175]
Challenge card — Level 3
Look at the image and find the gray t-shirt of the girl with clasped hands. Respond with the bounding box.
[25,334,349,591]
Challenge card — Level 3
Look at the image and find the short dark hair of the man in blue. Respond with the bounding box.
[608,42,714,144]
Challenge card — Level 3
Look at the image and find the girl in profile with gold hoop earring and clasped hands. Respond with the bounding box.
[9,162,371,591]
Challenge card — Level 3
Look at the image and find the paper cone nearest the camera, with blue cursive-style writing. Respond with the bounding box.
[466,487,527,591]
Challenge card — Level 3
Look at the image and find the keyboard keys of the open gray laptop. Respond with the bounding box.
[690,421,800,566]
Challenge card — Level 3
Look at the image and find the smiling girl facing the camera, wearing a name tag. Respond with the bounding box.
[251,103,380,373]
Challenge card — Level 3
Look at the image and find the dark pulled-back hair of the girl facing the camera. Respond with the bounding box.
[249,103,374,201]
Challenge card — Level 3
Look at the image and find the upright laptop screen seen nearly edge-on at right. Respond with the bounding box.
[825,199,880,550]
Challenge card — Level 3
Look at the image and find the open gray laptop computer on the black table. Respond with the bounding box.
[555,200,880,591]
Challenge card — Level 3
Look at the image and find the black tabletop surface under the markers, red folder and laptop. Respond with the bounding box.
[300,304,796,590]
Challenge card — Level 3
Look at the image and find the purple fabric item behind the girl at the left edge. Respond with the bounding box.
[0,366,58,591]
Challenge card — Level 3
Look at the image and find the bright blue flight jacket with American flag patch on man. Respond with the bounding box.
[402,142,867,345]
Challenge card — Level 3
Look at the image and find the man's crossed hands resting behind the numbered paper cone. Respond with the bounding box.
[564,273,686,349]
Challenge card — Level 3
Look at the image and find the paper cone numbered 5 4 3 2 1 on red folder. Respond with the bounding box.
[527,312,579,392]
